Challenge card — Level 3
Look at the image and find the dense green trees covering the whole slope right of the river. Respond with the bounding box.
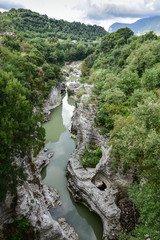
[82,28,160,240]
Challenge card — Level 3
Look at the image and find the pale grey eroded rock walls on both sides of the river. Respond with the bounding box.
[0,62,134,240]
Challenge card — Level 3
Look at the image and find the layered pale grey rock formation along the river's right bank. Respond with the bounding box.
[67,61,136,240]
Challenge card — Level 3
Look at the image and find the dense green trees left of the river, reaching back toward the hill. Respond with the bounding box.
[0,9,99,201]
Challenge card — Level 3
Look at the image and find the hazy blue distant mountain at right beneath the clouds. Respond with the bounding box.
[109,16,160,34]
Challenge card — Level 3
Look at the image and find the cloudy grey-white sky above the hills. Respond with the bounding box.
[0,0,160,30]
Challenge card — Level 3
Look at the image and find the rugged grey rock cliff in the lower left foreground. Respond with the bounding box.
[0,153,67,240]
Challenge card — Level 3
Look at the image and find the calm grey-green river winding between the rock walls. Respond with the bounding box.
[42,93,102,240]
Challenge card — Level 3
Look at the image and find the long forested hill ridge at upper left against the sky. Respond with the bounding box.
[0,9,107,40]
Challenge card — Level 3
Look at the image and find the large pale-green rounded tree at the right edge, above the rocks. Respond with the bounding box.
[110,99,160,184]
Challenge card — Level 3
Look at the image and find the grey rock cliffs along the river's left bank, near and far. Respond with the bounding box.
[0,86,77,240]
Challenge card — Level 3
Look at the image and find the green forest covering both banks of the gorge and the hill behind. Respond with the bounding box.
[0,9,160,240]
